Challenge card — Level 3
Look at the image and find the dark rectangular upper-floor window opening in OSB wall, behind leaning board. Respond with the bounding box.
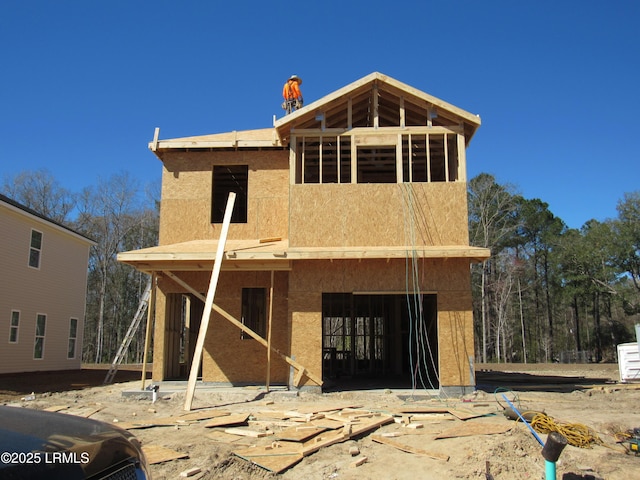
[211,165,249,223]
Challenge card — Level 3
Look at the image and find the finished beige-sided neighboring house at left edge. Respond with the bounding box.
[0,195,94,373]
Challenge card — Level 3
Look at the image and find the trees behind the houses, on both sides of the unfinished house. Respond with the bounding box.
[2,170,640,363]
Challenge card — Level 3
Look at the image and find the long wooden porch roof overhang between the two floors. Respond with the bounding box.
[118,239,491,273]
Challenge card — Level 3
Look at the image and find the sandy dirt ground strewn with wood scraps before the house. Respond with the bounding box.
[0,364,640,480]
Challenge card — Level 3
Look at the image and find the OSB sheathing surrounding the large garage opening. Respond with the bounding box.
[289,259,473,386]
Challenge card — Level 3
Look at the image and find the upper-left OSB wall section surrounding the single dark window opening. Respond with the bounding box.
[159,150,289,245]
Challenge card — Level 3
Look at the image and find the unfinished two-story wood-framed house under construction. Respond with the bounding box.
[118,73,490,394]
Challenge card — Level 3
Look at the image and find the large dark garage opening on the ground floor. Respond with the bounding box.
[322,293,439,389]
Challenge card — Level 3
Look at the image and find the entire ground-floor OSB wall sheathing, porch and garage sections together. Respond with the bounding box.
[154,259,473,386]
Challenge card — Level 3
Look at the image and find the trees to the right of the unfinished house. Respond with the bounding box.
[468,173,640,362]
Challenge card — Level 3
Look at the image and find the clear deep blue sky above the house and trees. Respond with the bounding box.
[0,0,640,228]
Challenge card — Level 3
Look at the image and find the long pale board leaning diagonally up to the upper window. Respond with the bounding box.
[184,192,236,411]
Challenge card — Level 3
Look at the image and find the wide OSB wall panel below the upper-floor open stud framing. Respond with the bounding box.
[289,182,469,247]
